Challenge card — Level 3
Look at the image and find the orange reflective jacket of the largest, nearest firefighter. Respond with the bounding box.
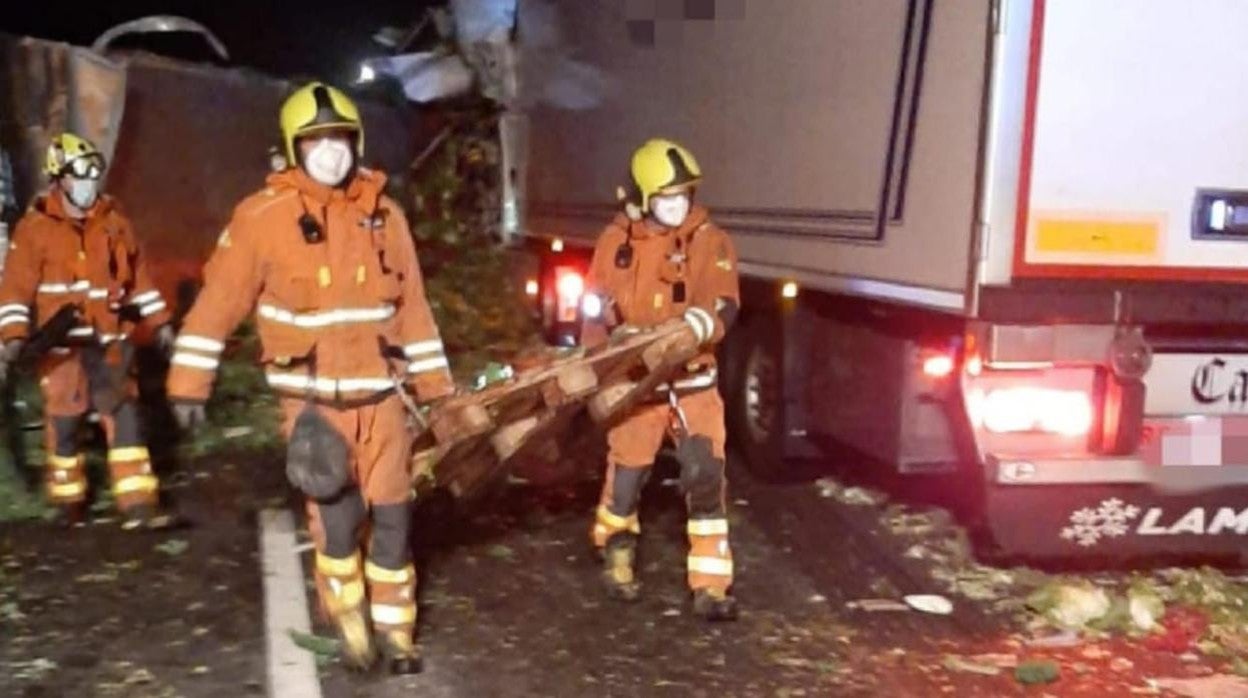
[167,169,454,405]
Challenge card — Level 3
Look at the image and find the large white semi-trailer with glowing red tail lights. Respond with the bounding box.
[520,0,1248,556]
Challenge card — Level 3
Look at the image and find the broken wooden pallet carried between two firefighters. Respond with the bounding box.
[412,320,698,499]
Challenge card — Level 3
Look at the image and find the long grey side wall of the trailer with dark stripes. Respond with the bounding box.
[529,0,990,310]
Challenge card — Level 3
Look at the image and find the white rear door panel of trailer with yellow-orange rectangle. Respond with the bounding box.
[1026,0,1248,277]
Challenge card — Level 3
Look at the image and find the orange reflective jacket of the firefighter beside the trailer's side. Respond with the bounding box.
[587,206,740,390]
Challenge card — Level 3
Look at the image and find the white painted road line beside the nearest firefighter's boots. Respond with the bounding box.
[260,509,321,698]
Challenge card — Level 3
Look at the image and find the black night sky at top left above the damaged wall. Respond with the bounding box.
[0,0,444,81]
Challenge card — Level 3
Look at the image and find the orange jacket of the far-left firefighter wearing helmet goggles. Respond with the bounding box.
[0,187,170,343]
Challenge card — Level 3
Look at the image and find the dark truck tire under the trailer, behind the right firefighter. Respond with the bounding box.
[723,316,791,482]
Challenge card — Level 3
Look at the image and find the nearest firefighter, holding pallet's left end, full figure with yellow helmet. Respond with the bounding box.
[168,82,454,673]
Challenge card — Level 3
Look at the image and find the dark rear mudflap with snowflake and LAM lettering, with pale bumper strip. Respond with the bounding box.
[985,458,1248,562]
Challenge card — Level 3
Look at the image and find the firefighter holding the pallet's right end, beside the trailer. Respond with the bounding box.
[587,140,739,621]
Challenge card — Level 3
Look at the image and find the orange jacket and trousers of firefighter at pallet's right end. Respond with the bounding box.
[587,206,740,592]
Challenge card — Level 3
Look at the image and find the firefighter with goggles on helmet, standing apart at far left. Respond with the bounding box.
[0,132,173,529]
